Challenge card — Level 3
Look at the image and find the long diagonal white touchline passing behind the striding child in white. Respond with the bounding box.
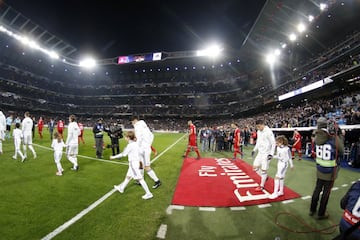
[41,135,185,240]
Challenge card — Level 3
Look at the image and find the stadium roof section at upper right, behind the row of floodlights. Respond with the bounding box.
[244,0,360,59]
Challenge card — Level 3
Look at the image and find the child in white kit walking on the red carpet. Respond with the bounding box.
[269,135,294,199]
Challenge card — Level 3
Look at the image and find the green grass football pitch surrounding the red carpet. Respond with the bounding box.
[0,129,360,240]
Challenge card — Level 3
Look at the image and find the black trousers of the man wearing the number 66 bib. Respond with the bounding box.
[310,178,334,216]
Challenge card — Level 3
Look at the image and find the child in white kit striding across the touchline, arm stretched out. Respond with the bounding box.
[110,131,153,200]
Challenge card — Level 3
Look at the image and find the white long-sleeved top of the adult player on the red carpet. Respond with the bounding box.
[254,126,276,155]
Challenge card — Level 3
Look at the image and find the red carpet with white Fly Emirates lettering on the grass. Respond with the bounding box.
[172,158,300,207]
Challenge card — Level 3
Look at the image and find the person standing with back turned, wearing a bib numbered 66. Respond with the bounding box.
[309,117,344,220]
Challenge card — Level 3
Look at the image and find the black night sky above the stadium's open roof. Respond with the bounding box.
[0,0,265,59]
